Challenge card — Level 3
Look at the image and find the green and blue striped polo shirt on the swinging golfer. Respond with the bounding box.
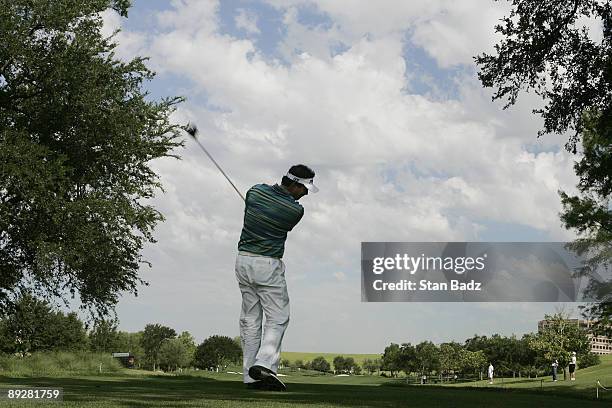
[238,184,304,258]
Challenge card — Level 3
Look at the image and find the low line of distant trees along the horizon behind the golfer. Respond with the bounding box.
[0,295,599,379]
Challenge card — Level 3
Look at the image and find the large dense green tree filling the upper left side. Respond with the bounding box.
[0,0,183,316]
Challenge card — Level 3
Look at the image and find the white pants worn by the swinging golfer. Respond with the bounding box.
[236,252,289,383]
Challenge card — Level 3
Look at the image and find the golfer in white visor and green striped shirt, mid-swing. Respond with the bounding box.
[236,164,318,391]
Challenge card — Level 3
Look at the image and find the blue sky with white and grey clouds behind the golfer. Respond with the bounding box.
[98,0,597,353]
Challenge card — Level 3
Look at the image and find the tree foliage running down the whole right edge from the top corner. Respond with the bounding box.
[475,0,612,328]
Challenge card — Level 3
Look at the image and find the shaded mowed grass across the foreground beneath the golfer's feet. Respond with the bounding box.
[0,362,612,408]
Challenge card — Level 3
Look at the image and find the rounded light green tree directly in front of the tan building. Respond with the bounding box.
[530,313,590,375]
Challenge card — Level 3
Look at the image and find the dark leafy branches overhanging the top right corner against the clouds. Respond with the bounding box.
[474,0,612,152]
